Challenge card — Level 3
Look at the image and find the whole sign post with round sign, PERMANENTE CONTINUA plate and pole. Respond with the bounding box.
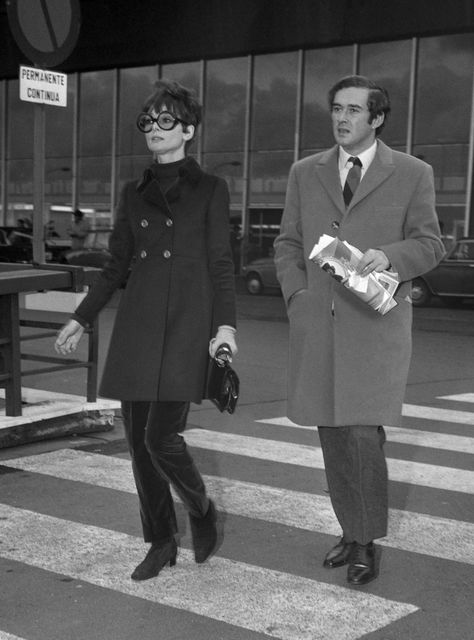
[7,0,81,263]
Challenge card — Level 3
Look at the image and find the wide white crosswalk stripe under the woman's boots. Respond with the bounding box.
[0,505,418,640]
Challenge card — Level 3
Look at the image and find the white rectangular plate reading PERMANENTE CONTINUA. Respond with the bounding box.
[20,66,67,107]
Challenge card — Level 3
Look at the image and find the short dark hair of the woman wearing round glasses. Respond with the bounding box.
[142,80,202,128]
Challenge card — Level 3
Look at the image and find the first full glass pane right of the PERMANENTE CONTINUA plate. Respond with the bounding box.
[79,71,114,156]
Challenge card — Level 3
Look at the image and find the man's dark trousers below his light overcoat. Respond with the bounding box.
[318,425,388,544]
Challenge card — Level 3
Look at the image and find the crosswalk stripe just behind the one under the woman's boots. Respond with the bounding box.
[6,449,474,564]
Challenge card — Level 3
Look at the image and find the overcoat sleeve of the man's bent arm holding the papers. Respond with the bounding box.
[378,159,445,282]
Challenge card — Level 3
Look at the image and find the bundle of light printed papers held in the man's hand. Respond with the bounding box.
[309,234,400,315]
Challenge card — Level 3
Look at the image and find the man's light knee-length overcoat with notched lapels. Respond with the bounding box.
[275,140,444,426]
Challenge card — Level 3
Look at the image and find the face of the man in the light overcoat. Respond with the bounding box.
[331,87,384,156]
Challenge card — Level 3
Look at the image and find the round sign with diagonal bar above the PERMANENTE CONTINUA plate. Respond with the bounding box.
[7,0,81,67]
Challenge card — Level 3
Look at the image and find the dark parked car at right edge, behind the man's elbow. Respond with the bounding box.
[412,238,474,307]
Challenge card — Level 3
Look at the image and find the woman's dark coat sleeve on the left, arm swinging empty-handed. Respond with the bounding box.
[72,185,134,325]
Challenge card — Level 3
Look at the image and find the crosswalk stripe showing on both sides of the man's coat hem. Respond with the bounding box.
[256,417,474,454]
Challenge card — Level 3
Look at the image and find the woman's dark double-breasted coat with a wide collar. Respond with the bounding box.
[74,158,235,402]
